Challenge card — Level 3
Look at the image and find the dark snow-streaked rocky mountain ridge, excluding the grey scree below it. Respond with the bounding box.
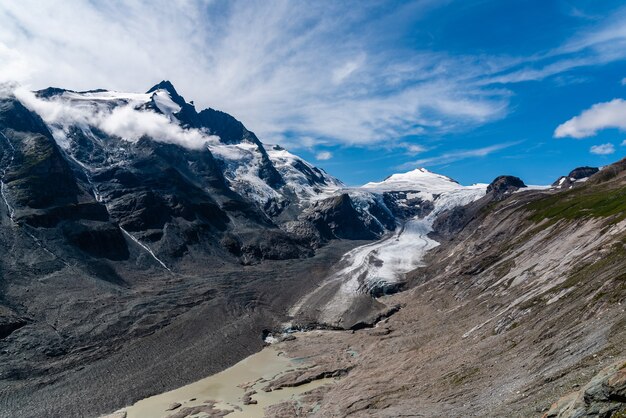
[1,81,478,264]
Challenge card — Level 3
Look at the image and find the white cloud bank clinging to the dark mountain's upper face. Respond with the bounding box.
[15,88,219,149]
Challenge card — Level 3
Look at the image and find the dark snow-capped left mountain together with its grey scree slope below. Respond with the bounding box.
[0,81,492,416]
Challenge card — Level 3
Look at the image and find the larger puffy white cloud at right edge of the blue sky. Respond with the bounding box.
[554,99,626,138]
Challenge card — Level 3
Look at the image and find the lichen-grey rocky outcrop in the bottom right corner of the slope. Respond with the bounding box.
[543,359,626,418]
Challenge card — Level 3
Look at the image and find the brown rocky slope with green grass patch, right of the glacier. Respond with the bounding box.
[268,160,626,417]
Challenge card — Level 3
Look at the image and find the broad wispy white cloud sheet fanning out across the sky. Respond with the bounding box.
[0,0,626,153]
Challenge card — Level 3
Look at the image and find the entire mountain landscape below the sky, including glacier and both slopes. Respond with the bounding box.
[0,81,626,417]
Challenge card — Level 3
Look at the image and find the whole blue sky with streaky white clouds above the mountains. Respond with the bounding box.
[0,0,626,185]
